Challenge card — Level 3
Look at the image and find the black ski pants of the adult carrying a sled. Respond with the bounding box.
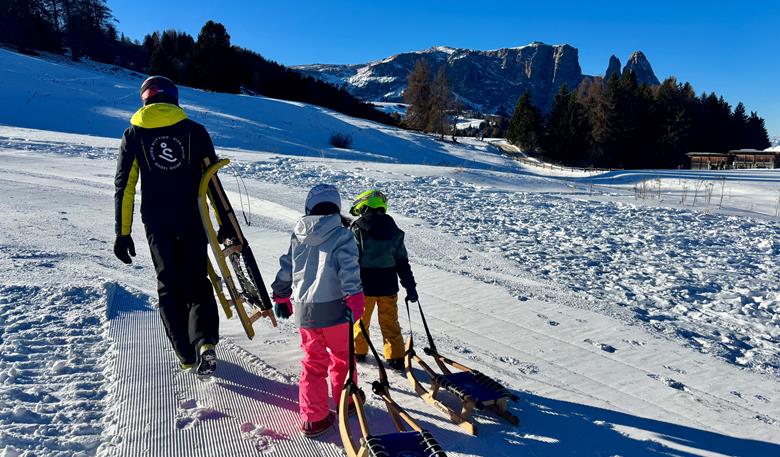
[146,225,219,364]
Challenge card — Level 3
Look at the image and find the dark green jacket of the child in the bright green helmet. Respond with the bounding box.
[352,213,416,296]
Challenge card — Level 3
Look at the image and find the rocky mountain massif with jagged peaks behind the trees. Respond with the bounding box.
[295,42,658,113]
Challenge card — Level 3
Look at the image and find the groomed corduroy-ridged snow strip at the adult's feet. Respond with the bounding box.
[108,287,342,457]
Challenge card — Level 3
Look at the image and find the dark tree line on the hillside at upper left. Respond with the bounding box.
[0,0,397,125]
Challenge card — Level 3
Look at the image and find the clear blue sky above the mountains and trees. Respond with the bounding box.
[108,0,780,135]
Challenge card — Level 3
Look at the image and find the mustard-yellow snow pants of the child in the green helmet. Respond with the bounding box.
[354,295,404,359]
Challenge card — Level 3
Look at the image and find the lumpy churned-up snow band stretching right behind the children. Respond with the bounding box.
[9,138,780,376]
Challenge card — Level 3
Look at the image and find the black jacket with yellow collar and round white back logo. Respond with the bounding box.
[114,103,217,235]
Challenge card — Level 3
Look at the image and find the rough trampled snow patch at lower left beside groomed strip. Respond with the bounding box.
[0,284,113,456]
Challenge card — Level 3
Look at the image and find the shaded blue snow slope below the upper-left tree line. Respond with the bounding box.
[0,48,513,168]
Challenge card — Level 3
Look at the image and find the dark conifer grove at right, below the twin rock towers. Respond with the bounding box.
[507,71,770,168]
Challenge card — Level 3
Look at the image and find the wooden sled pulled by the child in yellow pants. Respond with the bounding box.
[404,300,520,435]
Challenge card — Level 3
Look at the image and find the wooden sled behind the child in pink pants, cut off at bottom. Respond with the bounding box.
[338,319,447,457]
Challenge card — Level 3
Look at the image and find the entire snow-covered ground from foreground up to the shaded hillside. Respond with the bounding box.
[0,50,780,456]
